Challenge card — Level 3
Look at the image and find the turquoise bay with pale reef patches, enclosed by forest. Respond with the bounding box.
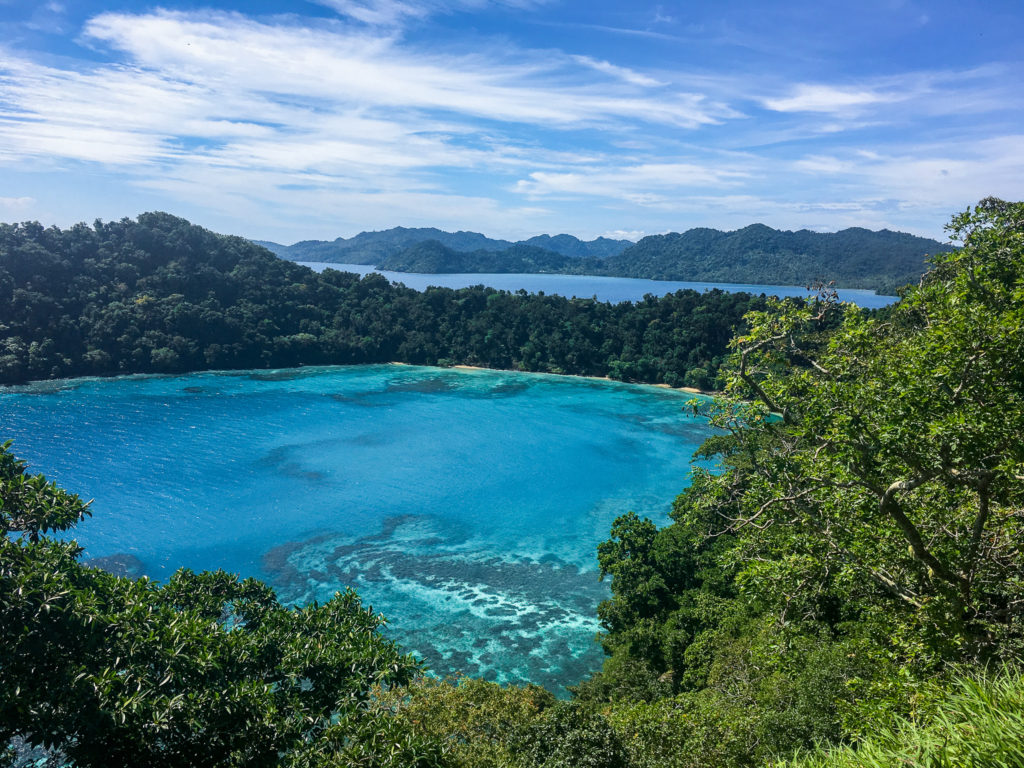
[0,366,709,693]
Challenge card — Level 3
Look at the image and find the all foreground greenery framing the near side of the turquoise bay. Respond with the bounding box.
[0,199,1024,768]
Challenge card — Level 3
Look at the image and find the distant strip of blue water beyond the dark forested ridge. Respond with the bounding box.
[298,261,896,309]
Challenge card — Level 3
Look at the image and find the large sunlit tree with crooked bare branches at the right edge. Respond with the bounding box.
[696,199,1024,660]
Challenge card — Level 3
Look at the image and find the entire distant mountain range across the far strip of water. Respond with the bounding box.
[255,224,951,293]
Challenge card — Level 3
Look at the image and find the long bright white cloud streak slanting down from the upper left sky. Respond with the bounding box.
[75,12,732,127]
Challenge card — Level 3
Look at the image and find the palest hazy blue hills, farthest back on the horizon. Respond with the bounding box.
[255,226,633,264]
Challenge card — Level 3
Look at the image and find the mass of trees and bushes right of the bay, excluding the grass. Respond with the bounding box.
[579,200,1024,766]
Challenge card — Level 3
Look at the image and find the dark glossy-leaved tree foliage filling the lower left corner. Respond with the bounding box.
[0,445,440,768]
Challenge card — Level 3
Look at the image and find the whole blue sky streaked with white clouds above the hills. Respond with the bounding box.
[0,0,1024,244]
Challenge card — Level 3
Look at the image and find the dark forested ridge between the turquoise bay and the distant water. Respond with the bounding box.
[0,213,765,388]
